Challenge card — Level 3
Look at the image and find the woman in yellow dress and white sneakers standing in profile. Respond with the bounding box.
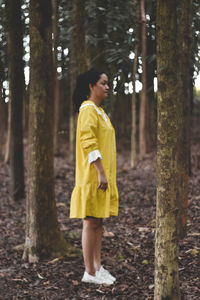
[70,69,118,284]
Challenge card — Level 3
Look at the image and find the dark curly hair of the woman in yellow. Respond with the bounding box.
[73,69,105,112]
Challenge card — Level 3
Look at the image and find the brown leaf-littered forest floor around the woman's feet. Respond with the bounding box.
[0,119,200,300]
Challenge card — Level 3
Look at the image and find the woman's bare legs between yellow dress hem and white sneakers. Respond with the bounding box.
[82,218,102,276]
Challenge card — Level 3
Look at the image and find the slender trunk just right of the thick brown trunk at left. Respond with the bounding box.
[52,0,60,153]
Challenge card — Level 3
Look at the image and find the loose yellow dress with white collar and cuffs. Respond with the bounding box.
[70,100,118,218]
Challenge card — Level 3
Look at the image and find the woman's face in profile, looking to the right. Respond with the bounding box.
[90,73,109,101]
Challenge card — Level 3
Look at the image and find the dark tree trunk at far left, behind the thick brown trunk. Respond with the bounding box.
[6,0,24,201]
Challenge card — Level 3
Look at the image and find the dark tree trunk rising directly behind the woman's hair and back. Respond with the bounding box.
[69,0,87,163]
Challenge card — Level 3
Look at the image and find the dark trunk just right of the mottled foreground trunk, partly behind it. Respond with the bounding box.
[178,0,192,238]
